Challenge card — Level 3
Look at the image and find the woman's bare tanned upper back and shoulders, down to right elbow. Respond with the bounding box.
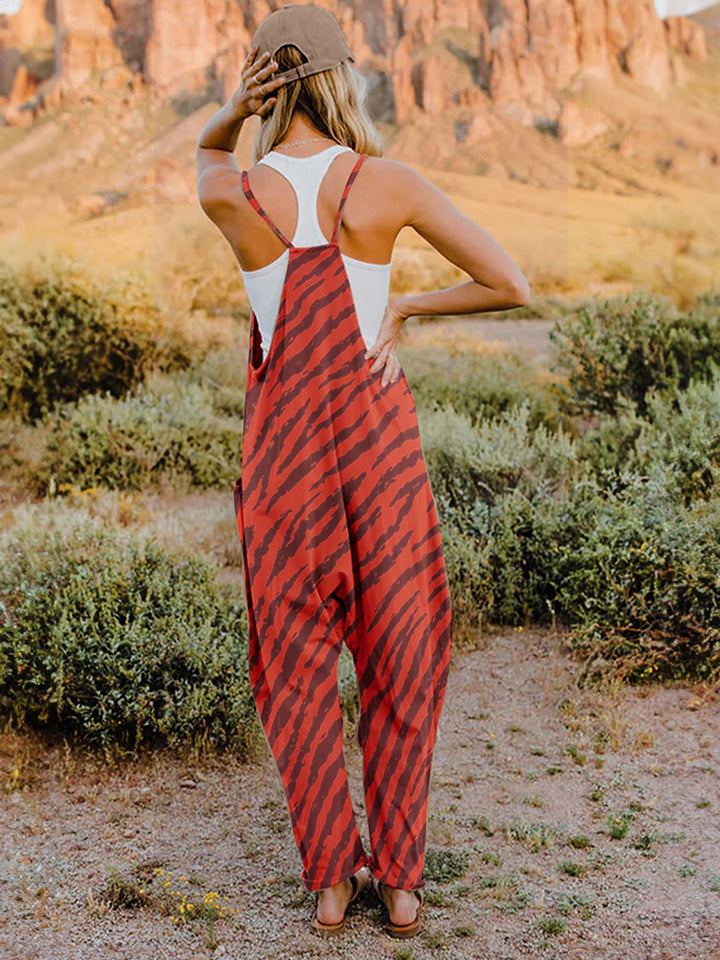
[198,150,525,304]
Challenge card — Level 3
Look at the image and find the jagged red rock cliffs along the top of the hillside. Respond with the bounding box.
[0,0,706,136]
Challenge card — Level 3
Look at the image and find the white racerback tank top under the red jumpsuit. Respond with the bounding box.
[240,144,392,357]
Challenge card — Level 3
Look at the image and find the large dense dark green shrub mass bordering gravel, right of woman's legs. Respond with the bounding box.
[438,466,720,682]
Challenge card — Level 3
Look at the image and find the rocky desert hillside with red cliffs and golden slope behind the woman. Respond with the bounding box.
[0,0,720,309]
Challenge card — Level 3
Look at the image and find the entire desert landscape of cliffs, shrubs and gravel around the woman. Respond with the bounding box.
[0,0,720,960]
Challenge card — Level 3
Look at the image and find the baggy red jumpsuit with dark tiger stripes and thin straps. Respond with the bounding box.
[234,155,451,890]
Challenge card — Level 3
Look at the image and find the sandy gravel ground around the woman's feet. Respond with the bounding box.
[0,630,720,960]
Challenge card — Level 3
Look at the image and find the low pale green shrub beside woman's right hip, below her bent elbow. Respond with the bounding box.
[402,347,563,427]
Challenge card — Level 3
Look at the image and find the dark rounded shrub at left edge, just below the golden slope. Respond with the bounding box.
[0,263,191,421]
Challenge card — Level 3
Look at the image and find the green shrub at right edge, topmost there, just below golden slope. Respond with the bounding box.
[550,291,720,416]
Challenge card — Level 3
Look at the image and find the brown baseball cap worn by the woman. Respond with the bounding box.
[250,3,355,81]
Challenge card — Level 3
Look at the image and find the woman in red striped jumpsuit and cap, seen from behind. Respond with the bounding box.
[197,4,529,937]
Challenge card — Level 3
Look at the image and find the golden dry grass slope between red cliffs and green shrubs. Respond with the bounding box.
[0,73,720,316]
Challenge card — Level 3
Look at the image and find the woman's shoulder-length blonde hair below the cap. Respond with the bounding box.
[253,44,383,163]
